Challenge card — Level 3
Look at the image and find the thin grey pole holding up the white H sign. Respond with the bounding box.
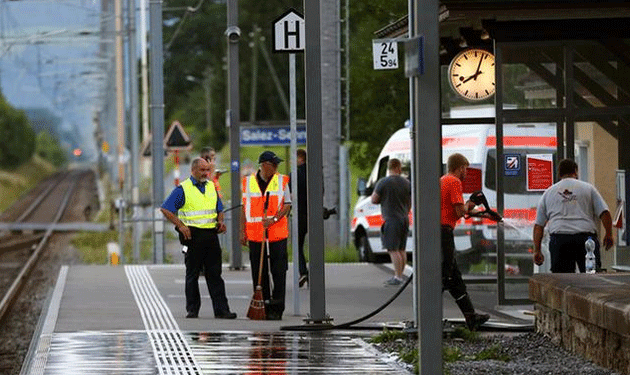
[289,53,300,316]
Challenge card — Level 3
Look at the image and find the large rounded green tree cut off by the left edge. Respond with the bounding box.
[0,95,35,169]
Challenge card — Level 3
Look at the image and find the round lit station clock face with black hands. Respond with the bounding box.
[448,48,495,102]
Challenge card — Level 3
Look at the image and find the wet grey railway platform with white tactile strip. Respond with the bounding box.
[22,264,533,375]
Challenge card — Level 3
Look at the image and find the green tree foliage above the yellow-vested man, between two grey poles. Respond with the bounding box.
[163,0,227,148]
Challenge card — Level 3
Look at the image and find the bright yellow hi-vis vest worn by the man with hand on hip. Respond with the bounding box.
[177,178,217,229]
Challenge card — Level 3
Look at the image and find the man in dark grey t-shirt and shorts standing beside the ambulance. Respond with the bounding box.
[372,158,411,285]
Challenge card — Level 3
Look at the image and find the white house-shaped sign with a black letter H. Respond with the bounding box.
[273,9,306,52]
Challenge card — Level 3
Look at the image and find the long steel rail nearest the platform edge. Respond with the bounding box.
[0,173,79,322]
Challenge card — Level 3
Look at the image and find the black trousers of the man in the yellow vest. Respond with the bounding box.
[184,227,230,316]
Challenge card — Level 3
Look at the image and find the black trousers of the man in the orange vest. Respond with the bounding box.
[249,238,289,316]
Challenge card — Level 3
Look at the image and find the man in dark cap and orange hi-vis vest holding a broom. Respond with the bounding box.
[241,151,291,320]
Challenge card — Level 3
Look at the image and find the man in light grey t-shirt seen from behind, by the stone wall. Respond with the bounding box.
[534,159,613,273]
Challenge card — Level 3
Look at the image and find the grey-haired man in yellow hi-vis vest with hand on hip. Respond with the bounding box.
[161,158,236,319]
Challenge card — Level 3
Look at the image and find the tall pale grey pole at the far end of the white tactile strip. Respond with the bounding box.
[127,0,142,263]
